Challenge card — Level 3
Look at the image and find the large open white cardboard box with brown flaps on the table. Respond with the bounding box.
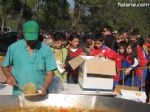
[69,56,116,90]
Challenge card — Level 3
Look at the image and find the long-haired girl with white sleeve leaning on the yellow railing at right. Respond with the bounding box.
[120,41,139,86]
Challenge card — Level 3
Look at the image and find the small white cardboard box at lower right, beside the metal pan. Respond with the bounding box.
[121,90,147,103]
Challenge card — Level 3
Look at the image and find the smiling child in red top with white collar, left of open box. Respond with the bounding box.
[67,33,85,84]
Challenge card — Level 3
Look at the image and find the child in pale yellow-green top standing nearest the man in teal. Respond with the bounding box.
[52,32,68,82]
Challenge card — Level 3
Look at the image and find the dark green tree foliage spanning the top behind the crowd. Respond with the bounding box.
[0,0,150,35]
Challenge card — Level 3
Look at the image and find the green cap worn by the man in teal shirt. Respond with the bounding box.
[23,20,40,40]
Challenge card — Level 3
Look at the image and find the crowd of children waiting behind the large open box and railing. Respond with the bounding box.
[44,25,150,101]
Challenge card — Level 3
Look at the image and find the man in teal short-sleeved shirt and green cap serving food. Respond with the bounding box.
[2,20,57,95]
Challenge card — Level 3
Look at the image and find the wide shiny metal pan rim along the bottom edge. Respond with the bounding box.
[0,94,150,112]
